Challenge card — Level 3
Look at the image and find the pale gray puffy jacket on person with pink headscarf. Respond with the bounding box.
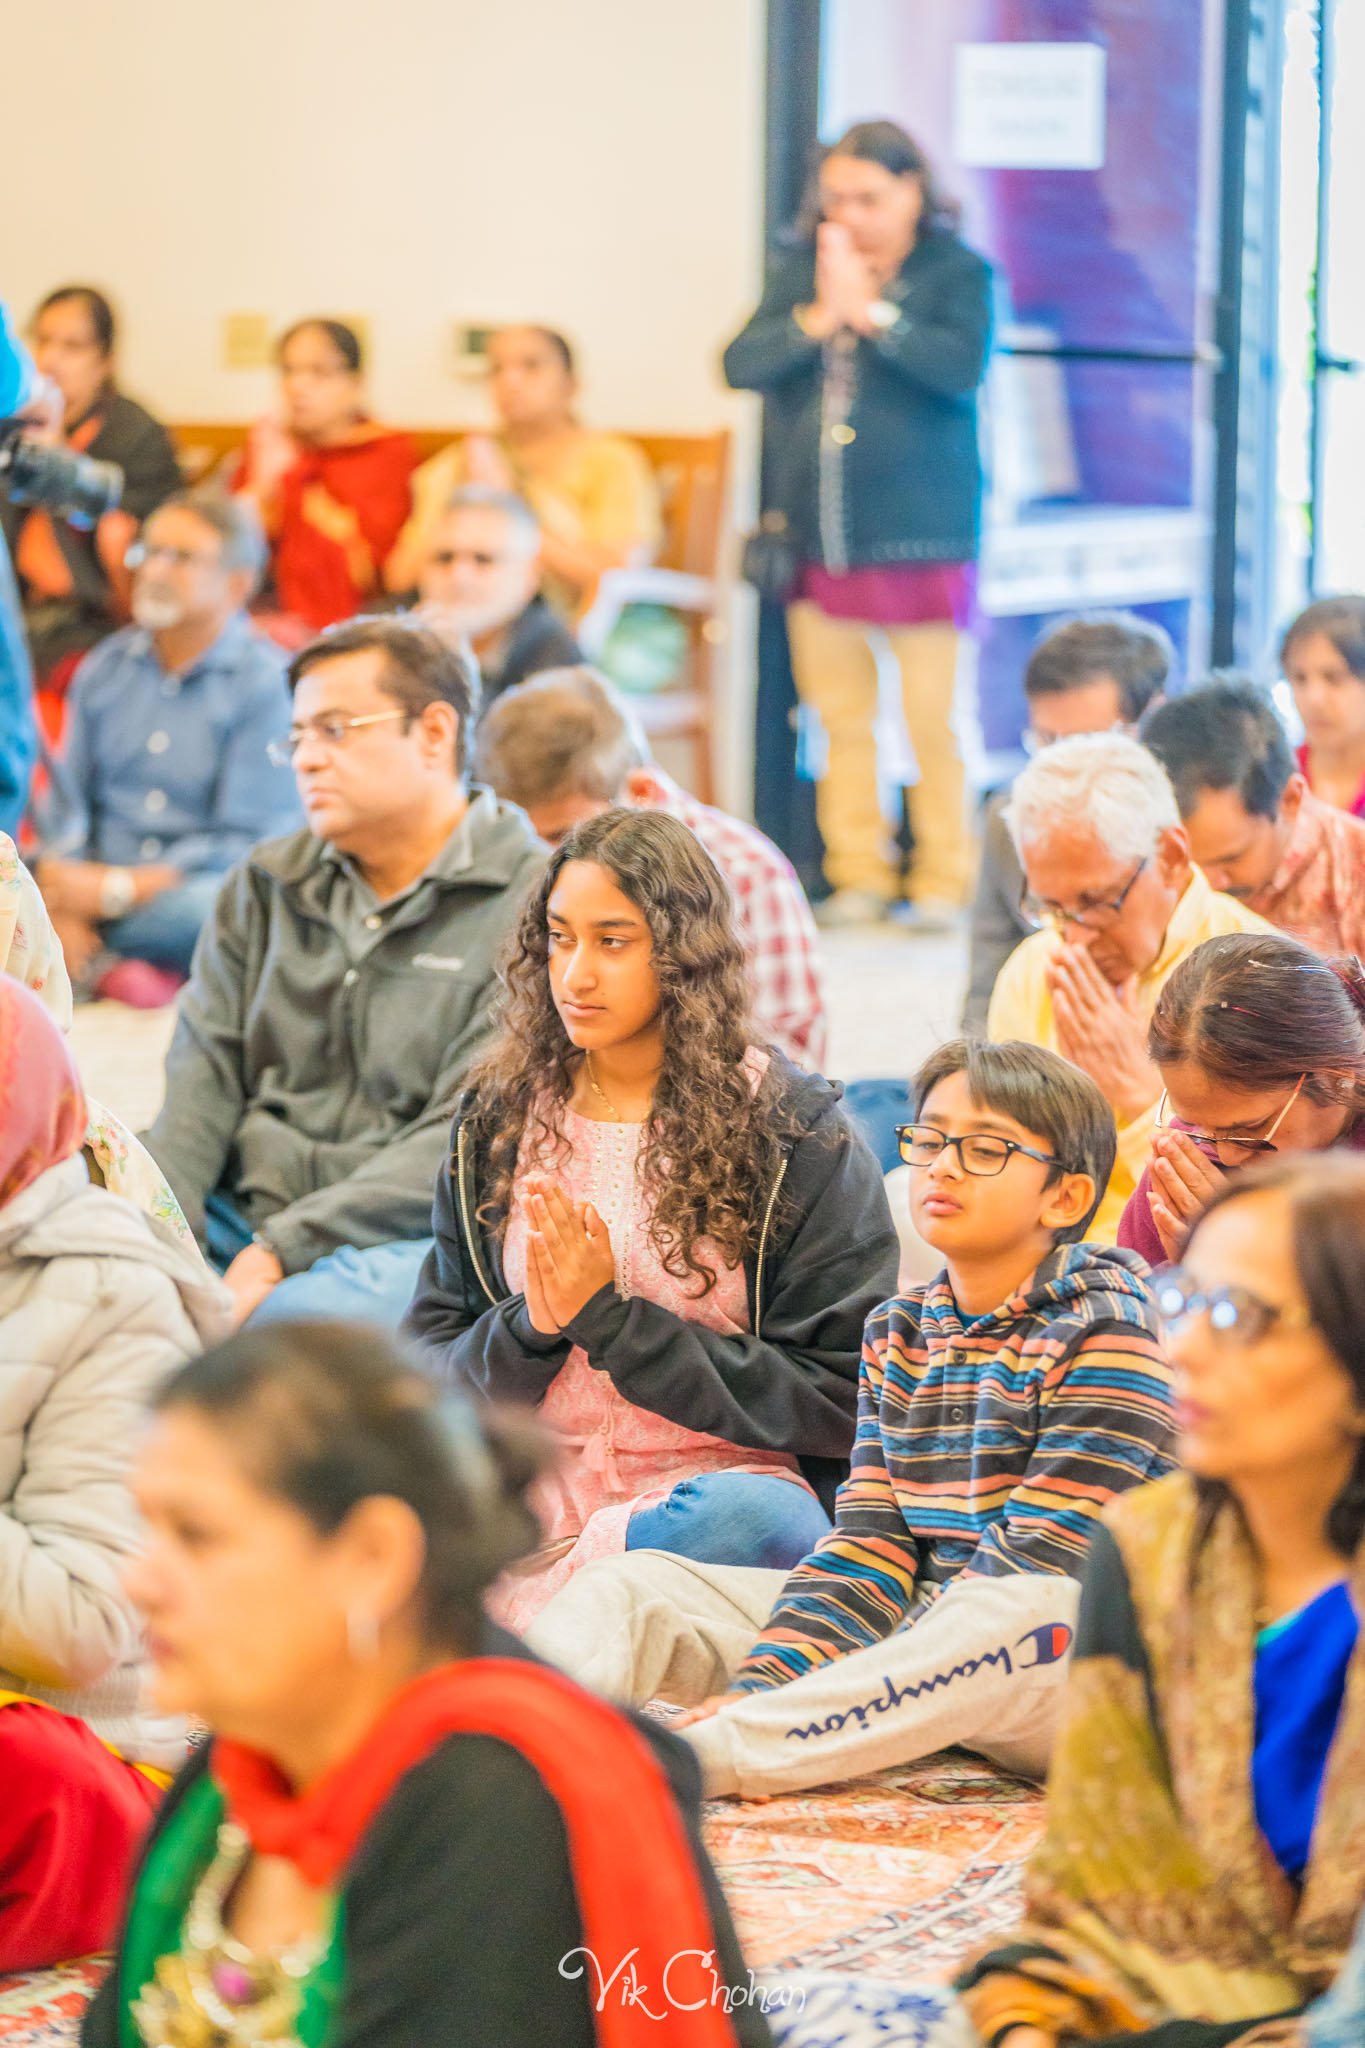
[0,1157,231,1769]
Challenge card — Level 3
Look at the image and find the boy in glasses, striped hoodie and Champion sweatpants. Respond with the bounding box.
[530,1040,1173,1796]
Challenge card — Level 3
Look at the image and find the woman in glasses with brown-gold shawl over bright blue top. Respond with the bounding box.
[958,1159,1365,2048]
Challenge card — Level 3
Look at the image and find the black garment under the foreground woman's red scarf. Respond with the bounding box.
[80,1630,772,2048]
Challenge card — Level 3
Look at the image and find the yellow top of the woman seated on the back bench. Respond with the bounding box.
[395,432,663,616]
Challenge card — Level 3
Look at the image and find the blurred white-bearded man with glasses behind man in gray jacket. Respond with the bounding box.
[405,483,583,709]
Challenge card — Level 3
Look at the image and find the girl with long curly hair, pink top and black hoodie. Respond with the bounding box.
[407,809,896,1626]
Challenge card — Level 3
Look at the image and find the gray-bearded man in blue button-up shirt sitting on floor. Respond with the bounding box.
[37,492,301,1001]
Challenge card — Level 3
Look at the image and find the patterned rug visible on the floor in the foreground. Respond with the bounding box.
[0,1751,1044,2048]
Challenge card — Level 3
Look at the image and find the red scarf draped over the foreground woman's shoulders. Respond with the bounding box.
[213,1657,735,2048]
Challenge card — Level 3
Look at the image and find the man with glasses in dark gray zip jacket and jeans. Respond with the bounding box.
[147,618,544,1323]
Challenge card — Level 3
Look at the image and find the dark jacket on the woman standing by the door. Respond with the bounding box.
[724,229,990,571]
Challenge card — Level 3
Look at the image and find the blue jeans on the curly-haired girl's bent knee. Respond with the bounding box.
[626,1473,829,1571]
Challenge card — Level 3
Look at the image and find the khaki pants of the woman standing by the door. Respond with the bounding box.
[786,600,970,903]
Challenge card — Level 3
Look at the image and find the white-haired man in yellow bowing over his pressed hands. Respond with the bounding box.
[986,733,1271,1243]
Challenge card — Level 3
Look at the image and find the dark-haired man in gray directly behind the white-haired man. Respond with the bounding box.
[962,612,1175,1032]
